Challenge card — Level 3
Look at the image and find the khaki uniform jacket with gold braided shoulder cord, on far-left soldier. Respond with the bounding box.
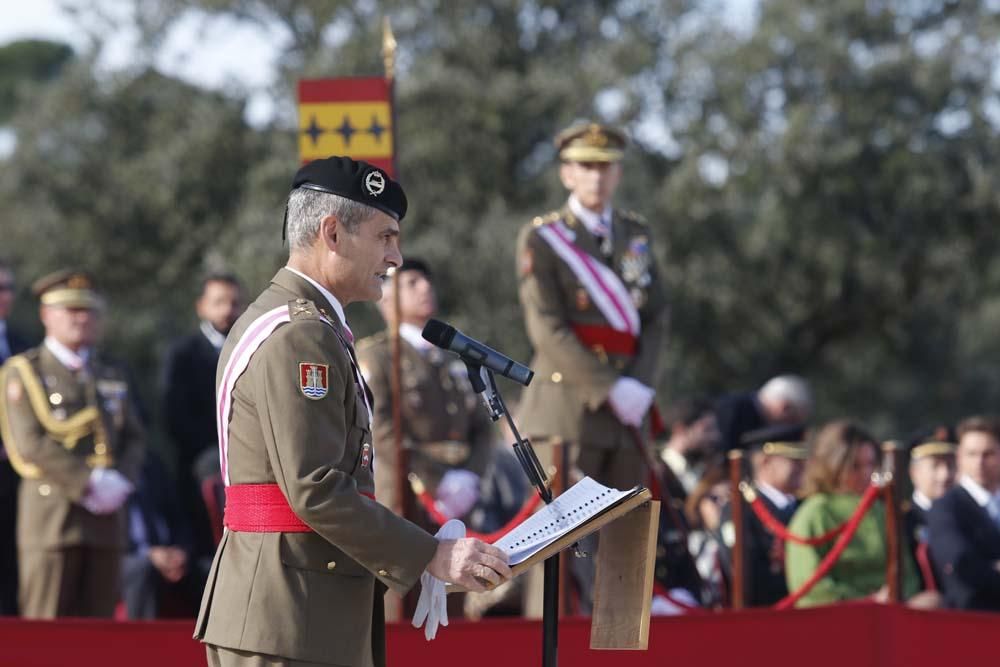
[0,345,145,550]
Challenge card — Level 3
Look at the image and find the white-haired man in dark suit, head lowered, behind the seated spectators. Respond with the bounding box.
[715,375,813,451]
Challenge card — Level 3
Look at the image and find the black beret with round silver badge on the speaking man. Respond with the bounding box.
[292,155,406,220]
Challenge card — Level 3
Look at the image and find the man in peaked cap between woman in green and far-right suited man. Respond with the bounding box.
[903,438,956,590]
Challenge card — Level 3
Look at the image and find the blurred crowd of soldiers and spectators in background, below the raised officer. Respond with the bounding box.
[0,260,1000,619]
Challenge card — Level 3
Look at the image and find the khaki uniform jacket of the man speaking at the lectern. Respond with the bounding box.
[195,269,437,667]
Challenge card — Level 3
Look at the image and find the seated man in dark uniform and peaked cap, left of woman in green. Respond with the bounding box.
[722,424,809,607]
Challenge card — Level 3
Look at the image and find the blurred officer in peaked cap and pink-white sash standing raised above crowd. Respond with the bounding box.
[517,123,667,488]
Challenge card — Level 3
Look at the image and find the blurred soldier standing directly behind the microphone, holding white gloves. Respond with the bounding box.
[358,258,495,529]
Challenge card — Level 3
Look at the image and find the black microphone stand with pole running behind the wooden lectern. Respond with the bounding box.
[463,366,559,667]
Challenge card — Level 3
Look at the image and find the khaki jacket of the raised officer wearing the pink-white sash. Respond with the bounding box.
[517,207,668,448]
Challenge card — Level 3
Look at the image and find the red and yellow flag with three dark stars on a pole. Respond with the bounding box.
[299,77,395,176]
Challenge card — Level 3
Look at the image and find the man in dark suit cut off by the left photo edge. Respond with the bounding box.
[0,259,28,616]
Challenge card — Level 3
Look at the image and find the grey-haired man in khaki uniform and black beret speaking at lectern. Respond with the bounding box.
[195,157,511,667]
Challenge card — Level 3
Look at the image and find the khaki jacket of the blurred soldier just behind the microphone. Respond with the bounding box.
[358,332,495,507]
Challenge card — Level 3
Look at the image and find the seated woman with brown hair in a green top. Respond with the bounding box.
[785,420,937,607]
